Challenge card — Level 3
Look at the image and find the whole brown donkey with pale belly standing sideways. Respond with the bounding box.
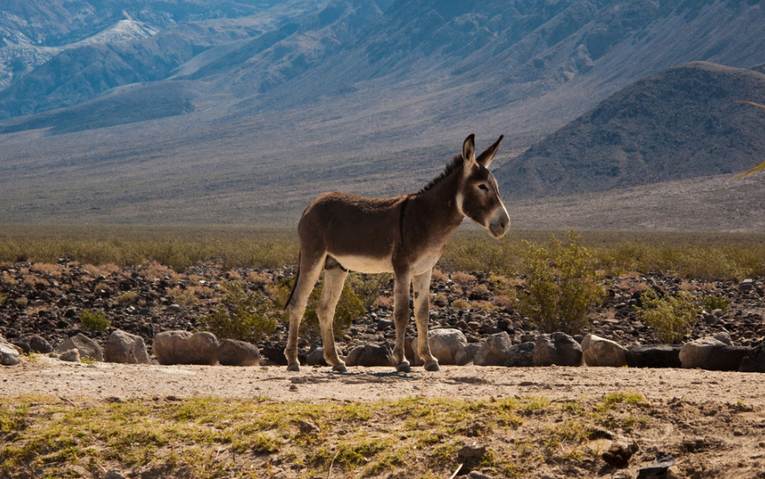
[284,135,510,371]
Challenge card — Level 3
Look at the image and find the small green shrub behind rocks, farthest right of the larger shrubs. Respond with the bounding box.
[637,289,699,343]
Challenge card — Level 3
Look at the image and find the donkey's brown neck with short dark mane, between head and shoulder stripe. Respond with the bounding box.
[409,166,465,244]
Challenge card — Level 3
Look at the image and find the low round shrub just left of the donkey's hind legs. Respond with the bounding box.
[202,282,280,342]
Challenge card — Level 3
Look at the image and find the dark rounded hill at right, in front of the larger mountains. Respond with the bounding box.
[497,62,765,197]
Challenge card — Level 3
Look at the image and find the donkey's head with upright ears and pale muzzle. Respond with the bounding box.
[457,134,510,238]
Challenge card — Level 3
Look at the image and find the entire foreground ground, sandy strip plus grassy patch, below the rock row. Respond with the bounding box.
[0,362,765,479]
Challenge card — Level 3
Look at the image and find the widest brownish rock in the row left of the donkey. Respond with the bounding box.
[153,331,218,364]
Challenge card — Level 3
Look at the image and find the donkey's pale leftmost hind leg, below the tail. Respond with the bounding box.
[284,250,326,371]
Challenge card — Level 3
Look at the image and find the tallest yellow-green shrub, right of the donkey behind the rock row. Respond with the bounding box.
[519,234,603,333]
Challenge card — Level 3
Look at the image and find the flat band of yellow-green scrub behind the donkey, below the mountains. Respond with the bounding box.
[0,226,765,282]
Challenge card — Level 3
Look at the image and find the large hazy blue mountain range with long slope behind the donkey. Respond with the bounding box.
[0,0,765,229]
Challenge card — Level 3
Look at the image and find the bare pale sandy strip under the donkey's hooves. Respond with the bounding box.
[0,357,765,406]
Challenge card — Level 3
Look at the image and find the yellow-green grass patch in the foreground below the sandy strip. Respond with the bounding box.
[0,392,664,479]
